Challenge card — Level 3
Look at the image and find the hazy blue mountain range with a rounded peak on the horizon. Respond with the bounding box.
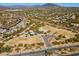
[0,3,59,9]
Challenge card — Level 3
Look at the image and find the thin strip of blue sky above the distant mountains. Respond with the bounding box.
[0,3,79,7]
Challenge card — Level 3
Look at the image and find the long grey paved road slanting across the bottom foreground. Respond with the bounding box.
[11,45,79,56]
